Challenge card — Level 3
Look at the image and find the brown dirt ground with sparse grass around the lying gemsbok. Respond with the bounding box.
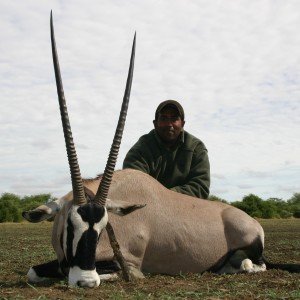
[0,219,300,300]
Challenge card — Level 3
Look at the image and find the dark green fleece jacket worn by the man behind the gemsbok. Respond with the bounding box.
[123,129,210,199]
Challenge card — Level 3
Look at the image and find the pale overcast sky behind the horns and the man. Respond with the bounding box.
[0,0,300,201]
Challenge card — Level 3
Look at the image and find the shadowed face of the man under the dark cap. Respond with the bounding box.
[153,106,185,147]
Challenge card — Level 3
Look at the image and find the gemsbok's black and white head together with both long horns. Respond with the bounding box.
[45,12,136,287]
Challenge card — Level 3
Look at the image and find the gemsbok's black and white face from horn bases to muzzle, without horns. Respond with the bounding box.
[63,202,108,287]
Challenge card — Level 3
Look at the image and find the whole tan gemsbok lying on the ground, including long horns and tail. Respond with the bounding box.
[23,13,300,287]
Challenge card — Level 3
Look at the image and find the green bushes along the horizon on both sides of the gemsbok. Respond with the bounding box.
[0,193,300,223]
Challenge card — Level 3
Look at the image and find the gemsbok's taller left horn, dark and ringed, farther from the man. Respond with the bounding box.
[50,11,86,205]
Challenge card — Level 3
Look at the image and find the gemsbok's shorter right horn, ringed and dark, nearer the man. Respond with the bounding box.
[95,33,136,206]
